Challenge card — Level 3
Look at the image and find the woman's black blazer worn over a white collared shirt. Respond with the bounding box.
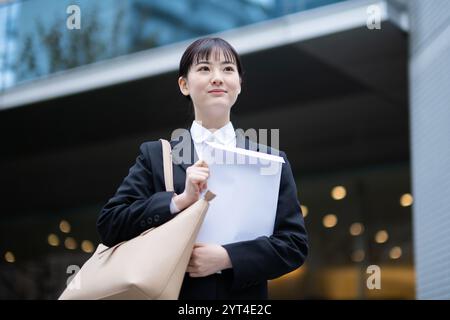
[97,130,308,299]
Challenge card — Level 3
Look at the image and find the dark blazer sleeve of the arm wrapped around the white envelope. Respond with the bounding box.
[223,151,308,290]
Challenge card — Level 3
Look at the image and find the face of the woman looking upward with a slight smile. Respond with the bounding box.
[178,50,241,117]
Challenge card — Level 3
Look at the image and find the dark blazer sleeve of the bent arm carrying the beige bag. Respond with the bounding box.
[97,141,174,247]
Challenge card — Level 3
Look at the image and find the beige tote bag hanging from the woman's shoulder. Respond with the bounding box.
[59,139,215,300]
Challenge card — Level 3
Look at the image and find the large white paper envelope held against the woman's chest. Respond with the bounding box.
[197,143,284,245]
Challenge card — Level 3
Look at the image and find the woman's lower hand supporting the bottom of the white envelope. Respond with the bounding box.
[186,243,232,277]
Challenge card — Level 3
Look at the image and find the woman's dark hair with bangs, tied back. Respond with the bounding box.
[178,37,244,100]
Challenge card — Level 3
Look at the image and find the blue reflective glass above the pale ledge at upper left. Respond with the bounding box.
[0,0,344,91]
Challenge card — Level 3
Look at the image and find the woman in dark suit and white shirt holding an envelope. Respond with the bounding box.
[97,38,308,299]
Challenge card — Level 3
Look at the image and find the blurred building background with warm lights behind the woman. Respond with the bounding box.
[0,0,450,299]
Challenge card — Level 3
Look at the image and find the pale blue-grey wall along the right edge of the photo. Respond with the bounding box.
[409,0,450,299]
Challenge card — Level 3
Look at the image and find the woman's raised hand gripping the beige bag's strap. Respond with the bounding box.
[173,160,209,210]
